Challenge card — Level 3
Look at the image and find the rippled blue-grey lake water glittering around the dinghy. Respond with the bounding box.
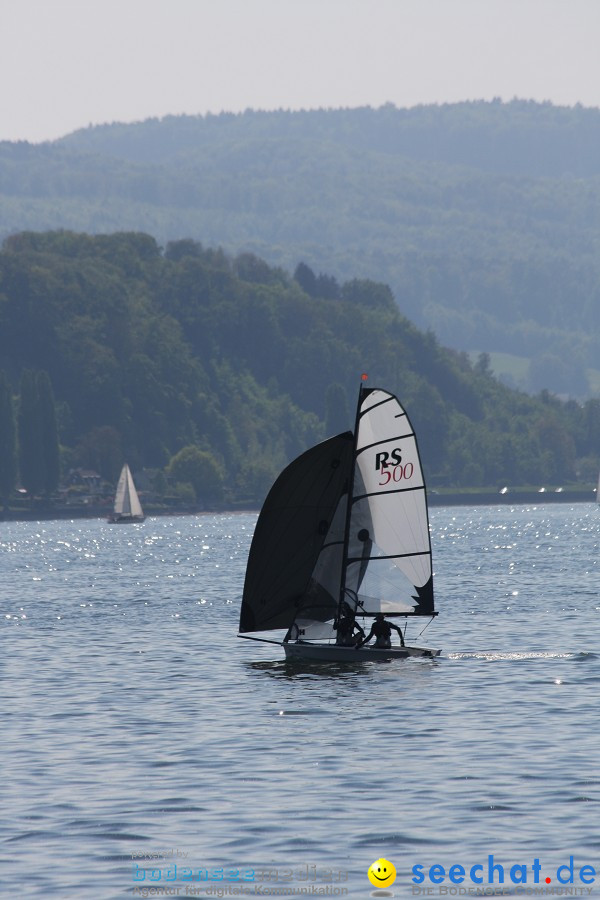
[0,503,600,900]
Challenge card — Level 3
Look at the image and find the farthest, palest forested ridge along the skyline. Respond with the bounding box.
[55,100,600,178]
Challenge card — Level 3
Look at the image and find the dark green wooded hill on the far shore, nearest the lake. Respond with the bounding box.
[0,232,600,502]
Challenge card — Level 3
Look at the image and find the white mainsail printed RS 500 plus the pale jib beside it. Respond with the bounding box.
[295,389,435,639]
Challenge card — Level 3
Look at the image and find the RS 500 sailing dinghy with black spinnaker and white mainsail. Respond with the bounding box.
[239,376,441,662]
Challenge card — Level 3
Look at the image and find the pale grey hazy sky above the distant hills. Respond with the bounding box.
[0,0,600,141]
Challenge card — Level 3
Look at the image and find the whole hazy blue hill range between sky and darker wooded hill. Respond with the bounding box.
[0,101,600,398]
